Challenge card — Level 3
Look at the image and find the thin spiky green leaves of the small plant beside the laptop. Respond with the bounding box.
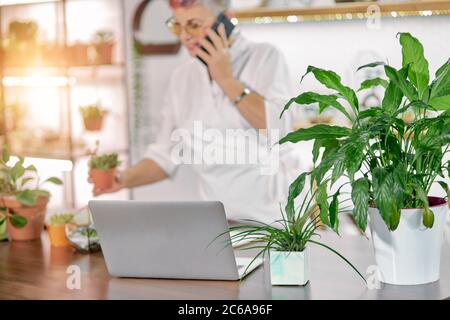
[221,186,365,282]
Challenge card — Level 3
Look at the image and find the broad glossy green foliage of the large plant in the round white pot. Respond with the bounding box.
[280,33,450,230]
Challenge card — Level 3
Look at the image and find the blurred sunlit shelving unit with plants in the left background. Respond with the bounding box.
[0,0,129,208]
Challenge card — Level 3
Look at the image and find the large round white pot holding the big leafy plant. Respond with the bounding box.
[369,197,448,285]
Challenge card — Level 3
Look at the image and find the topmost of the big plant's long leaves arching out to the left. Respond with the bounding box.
[302,66,359,114]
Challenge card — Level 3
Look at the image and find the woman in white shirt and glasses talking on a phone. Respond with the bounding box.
[94,0,299,223]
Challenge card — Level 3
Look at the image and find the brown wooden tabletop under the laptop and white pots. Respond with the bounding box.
[0,218,450,300]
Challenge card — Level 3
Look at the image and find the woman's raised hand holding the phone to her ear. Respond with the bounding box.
[196,24,233,86]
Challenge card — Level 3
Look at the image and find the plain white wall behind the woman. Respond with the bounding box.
[125,0,450,200]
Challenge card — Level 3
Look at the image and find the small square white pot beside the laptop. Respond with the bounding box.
[270,247,309,286]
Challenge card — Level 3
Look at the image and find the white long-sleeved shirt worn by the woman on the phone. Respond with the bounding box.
[144,33,302,223]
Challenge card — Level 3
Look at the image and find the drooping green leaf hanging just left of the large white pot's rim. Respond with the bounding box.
[352,177,369,231]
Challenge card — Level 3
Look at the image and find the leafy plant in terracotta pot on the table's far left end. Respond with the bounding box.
[0,148,62,240]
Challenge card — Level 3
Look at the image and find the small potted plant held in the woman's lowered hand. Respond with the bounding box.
[89,153,120,189]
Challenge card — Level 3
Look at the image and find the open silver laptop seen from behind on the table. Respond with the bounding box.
[89,200,262,280]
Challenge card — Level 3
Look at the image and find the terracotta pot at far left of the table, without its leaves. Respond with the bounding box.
[2,197,48,241]
